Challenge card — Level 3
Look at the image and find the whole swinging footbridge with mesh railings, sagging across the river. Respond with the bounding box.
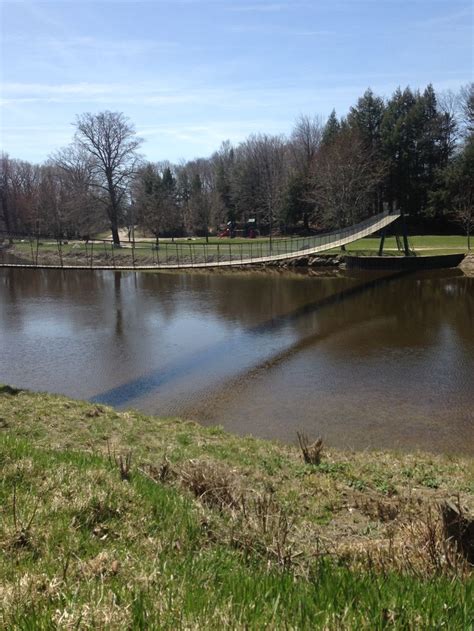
[0,211,400,270]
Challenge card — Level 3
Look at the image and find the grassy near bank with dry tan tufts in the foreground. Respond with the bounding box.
[0,387,474,629]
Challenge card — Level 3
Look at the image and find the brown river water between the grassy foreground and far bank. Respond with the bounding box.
[0,269,474,455]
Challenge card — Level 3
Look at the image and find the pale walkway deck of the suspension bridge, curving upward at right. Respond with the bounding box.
[0,212,400,270]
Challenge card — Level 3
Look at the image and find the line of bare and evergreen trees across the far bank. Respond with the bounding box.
[0,83,474,245]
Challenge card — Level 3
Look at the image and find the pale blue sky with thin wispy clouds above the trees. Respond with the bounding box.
[0,0,474,162]
